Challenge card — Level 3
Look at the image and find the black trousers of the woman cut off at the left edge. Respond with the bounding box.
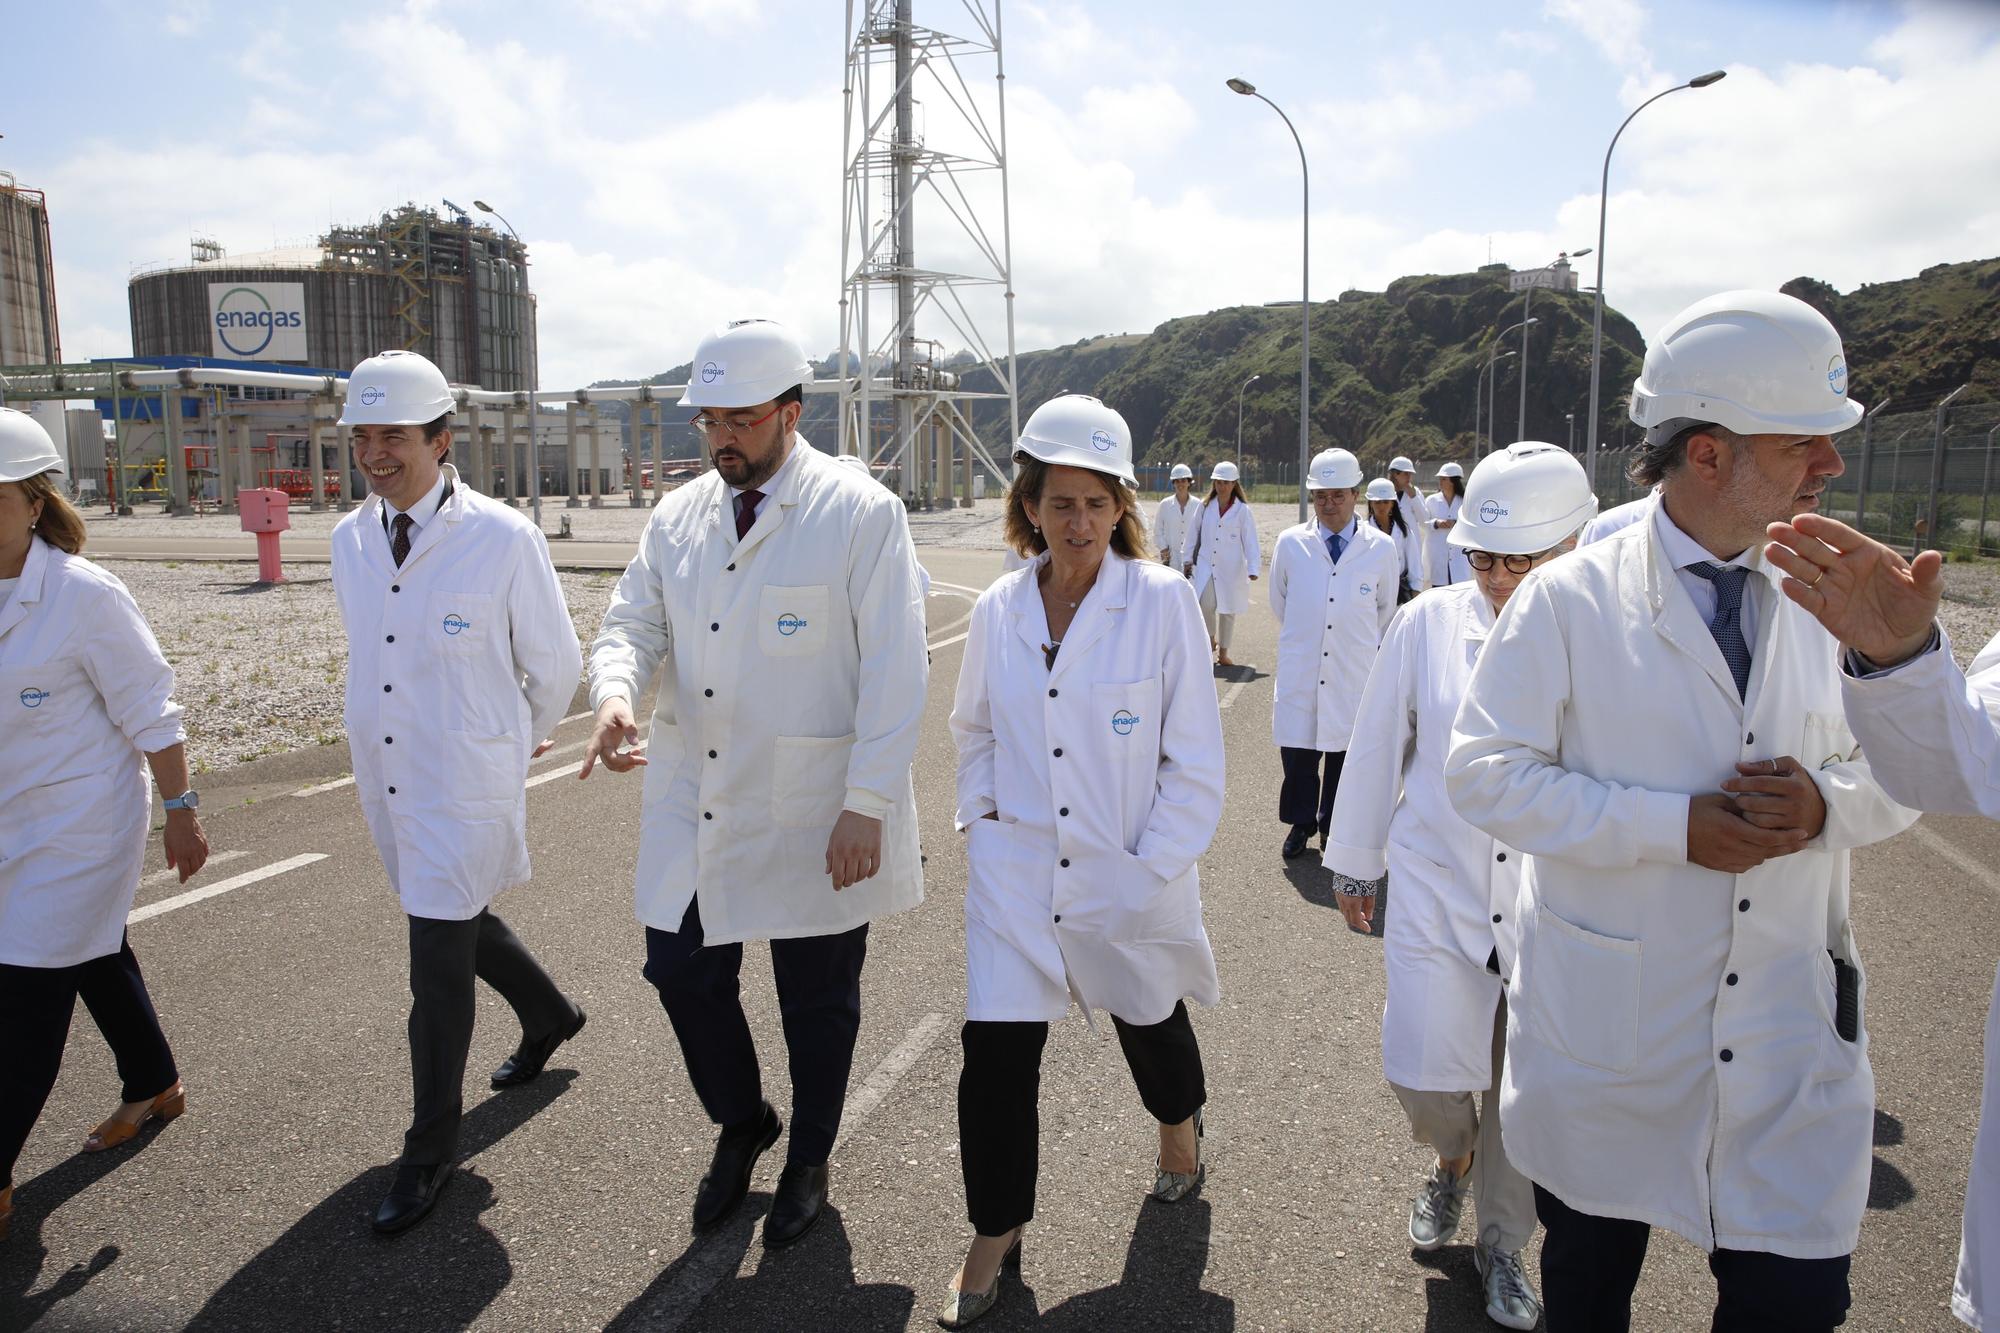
[0,943,180,1187]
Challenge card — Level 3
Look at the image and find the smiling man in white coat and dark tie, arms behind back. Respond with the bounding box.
[332,352,584,1233]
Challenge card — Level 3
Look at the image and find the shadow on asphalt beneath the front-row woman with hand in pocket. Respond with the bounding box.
[1032,1197,1236,1333]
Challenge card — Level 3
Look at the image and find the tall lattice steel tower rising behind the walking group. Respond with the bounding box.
[838,0,1020,506]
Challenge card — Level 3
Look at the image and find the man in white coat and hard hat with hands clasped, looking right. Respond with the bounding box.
[1446,292,1916,1333]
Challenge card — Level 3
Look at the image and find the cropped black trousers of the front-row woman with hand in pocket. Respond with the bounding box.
[958,1003,1208,1235]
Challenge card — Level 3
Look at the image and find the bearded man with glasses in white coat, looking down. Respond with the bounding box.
[582,320,926,1247]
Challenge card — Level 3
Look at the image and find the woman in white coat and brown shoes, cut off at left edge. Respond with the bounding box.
[0,408,208,1239]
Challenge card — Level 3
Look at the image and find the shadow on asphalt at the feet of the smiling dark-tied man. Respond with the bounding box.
[188,1069,576,1331]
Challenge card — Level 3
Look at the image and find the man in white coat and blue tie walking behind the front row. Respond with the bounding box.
[1268,448,1402,861]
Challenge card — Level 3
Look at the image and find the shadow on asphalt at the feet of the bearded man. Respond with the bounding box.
[604,1195,916,1333]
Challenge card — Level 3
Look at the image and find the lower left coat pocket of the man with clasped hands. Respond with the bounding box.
[1516,907,1640,1073]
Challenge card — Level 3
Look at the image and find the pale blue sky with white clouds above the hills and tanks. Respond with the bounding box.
[0,0,2000,386]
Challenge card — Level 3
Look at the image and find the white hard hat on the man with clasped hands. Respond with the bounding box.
[1630,292,1864,444]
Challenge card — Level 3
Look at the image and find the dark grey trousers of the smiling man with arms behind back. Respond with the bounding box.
[402,911,576,1167]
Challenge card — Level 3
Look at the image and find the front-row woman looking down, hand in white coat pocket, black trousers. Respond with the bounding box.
[938,394,1222,1329]
